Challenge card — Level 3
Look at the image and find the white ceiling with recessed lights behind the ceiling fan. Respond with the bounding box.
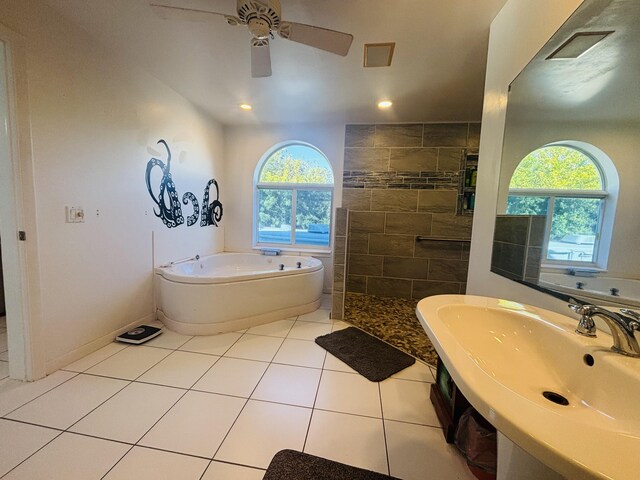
[46,0,506,125]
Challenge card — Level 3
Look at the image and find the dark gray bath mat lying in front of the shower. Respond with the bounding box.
[316,327,416,382]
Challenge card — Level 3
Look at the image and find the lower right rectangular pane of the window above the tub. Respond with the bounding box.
[296,190,331,247]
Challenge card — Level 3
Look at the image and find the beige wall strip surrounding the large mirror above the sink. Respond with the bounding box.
[467,0,582,313]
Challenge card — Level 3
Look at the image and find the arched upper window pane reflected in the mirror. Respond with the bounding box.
[509,146,604,190]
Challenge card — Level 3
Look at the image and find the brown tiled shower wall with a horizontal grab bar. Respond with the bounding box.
[334,123,480,304]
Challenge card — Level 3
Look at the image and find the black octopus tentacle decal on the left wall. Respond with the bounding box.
[145,139,222,228]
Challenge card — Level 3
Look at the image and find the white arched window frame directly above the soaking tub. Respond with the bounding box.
[252,141,335,253]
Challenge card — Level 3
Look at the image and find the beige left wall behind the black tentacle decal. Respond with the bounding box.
[0,0,226,371]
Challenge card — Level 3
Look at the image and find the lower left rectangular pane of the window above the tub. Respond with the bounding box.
[258,189,292,244]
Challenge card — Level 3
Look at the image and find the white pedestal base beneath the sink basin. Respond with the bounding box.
[496,432,566,480]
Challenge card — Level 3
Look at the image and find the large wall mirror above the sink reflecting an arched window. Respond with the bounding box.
[491,0,640,307]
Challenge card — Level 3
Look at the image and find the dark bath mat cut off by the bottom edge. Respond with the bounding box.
[262,450,399,480]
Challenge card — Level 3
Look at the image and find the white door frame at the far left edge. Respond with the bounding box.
[0,23,46,381]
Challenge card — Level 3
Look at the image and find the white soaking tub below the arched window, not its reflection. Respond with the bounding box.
[155,253,324,335]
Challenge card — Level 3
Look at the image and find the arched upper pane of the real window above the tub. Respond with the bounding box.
[258,145,333,185]
